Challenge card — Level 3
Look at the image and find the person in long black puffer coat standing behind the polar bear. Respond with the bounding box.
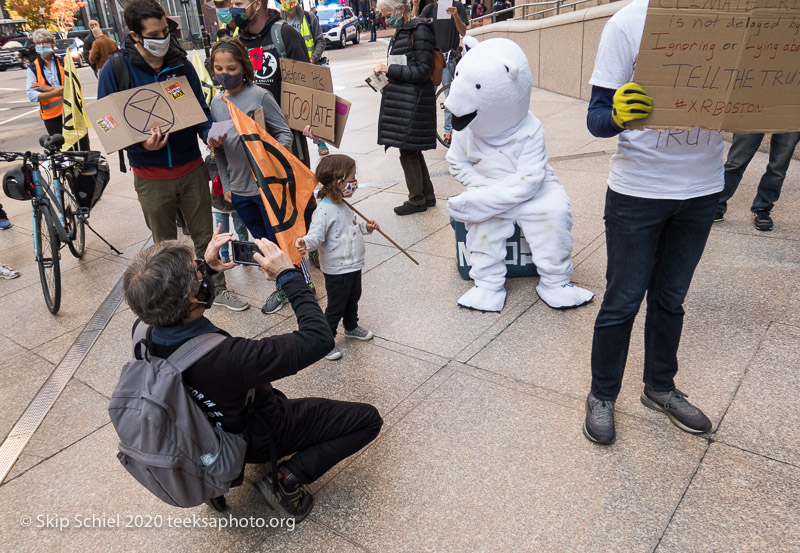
[374,0,436,215]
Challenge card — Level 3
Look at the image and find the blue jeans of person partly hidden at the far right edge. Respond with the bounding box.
[719,132,800,213]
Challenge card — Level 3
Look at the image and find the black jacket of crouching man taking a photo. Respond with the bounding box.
[145,271,334,462]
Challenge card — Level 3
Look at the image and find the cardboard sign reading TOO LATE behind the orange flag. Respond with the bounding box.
[280,58,350,147]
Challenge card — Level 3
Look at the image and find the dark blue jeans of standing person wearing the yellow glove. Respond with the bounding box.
[592,189,719,401]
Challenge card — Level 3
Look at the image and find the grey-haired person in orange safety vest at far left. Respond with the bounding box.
[25,29,89,151]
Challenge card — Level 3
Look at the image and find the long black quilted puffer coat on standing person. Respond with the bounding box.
[378,17,436,150]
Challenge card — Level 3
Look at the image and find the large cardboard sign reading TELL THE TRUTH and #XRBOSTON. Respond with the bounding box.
[629,0,800,133]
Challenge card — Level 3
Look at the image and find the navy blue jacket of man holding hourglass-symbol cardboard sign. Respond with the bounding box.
[97,31,211,167]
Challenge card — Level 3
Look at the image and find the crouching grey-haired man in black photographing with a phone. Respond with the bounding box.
[123,228,383,522]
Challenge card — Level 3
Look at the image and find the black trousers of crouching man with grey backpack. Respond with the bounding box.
[256,397,383,484]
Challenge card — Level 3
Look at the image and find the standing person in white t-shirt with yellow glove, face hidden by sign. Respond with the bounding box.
[583,0,723,444]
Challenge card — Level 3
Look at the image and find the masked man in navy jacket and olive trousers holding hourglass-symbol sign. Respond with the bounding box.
[97,0,249,311]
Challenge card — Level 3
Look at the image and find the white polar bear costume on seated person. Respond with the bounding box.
[445,36,594,311]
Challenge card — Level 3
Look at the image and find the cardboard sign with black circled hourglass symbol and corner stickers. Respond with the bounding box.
[86,77,206,154]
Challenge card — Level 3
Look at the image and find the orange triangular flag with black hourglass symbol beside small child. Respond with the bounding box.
[223,96,317,265]
